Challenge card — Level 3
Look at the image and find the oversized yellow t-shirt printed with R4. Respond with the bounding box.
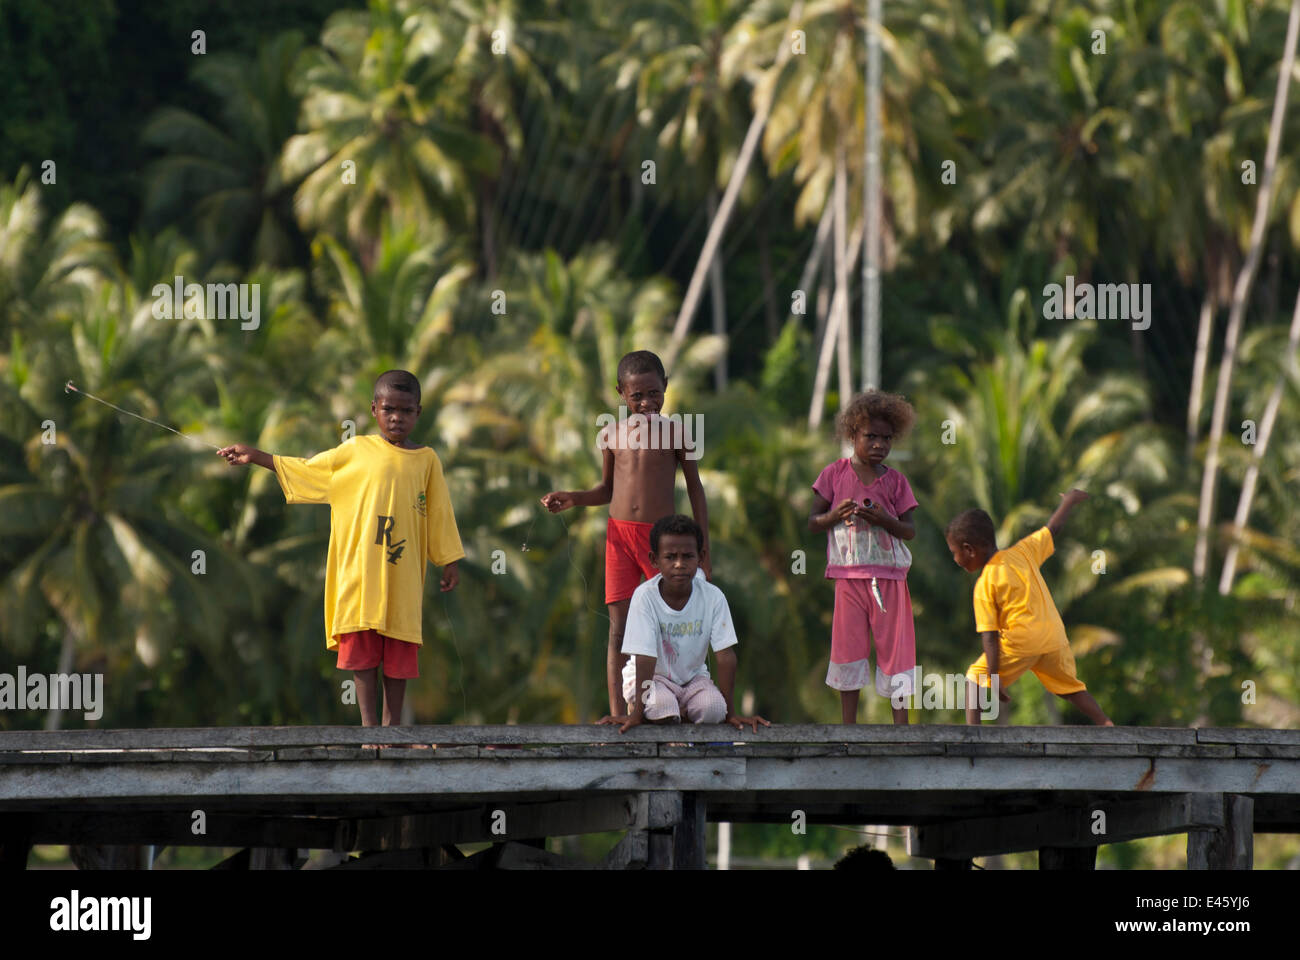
[273,436,465,650]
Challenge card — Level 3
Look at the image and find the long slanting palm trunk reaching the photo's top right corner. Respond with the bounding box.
[1192,0,1300,581]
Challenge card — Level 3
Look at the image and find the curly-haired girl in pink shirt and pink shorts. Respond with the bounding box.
[809,390,917,723]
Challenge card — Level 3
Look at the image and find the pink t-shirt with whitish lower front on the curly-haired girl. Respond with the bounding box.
[813,457,917,580]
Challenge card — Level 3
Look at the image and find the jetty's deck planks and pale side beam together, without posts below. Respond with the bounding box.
[0,725,1300,809]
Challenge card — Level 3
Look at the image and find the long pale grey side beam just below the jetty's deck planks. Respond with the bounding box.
[0,753,1300,809]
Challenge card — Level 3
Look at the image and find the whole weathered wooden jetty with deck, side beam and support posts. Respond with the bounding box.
[0,725,1300,869]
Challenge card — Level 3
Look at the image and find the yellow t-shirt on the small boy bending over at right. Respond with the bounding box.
[975,527,1067,656]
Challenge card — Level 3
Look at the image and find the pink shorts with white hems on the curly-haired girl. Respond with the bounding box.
[826,578,917,697]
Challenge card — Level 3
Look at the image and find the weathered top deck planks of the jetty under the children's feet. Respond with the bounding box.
[0,725,1300,766]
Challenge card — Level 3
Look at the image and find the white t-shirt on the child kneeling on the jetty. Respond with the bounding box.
[623,570,740,687]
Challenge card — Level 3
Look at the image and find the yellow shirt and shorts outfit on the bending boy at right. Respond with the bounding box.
[966,527,1087,695]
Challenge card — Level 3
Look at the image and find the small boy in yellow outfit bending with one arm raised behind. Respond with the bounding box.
[944,490,1114,727]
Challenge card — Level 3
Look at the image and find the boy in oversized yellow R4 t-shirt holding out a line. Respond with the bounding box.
[217,369,465,727]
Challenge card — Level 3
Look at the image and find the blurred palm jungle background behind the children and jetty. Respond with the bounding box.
[0,0,1300,866]
